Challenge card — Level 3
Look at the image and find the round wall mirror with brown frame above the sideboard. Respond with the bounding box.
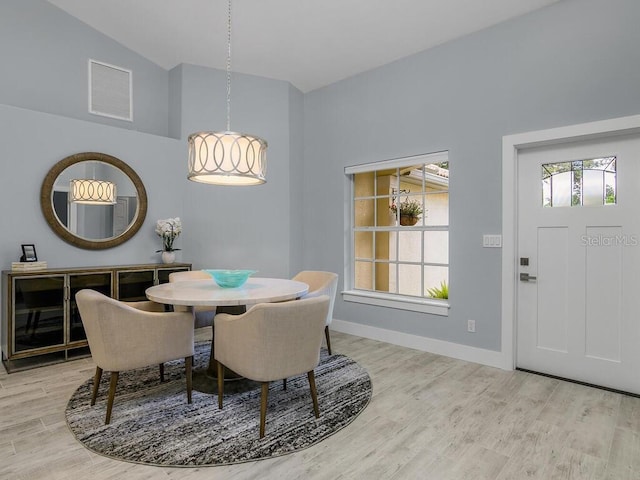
[40,152,147,250]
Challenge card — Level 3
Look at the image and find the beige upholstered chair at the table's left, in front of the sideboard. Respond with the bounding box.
[76,289,194,424]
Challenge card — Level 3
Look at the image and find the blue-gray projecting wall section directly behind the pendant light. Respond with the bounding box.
[175,65,301,277]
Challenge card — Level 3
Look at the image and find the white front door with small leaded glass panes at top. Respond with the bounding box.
[516,135,640,393]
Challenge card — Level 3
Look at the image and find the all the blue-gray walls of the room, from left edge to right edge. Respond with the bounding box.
[0,0,640,356]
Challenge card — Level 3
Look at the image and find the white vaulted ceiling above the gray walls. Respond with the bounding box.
[48,0,559,92]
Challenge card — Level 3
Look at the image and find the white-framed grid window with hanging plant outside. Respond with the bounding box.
[344,152,449,315]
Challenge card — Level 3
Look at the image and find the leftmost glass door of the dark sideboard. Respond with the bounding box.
[13,275,65,352]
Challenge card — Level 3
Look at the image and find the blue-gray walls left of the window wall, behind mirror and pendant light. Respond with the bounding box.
[0,0,302,277]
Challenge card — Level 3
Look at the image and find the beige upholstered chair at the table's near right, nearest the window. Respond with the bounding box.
[214,295,330,438]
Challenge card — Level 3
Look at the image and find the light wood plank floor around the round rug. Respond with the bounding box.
[0,330,640,480]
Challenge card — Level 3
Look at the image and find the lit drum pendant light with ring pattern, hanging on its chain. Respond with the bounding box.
[187,0,267,185]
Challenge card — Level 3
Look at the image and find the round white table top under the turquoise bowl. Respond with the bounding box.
[146,278,309,307]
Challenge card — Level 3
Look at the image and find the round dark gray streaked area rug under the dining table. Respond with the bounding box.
[65,342,371,467]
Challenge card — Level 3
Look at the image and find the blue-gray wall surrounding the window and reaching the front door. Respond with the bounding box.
[303,0,640,350]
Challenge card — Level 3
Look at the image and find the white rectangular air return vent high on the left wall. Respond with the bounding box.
[89,60,133,121]
